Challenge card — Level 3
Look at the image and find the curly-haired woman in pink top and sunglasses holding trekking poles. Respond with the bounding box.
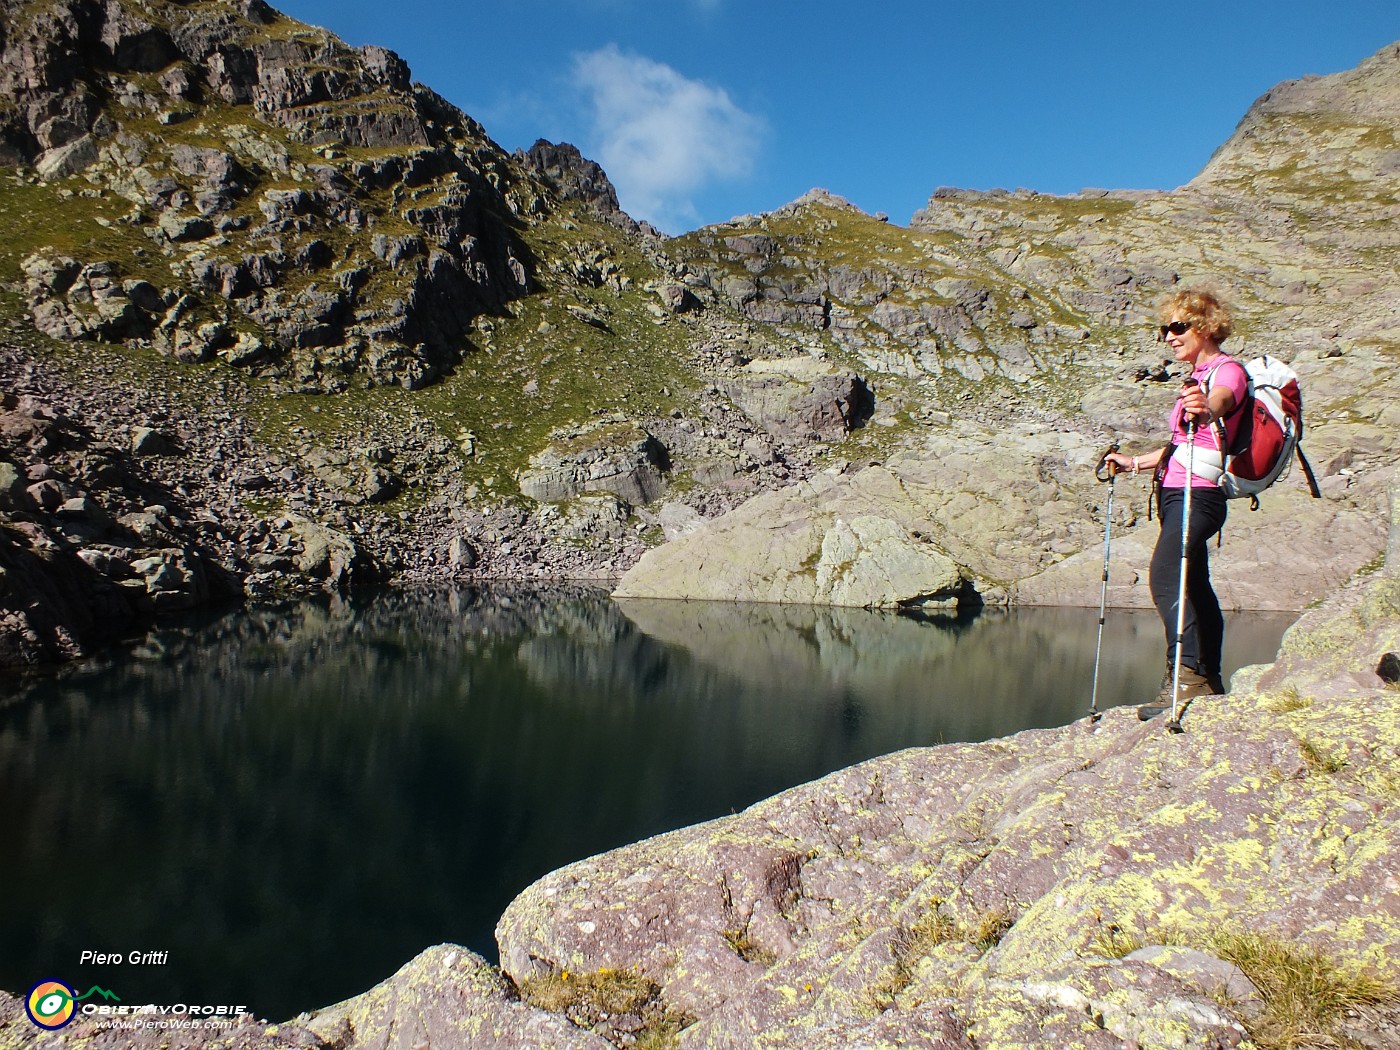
[1107,290,1249,717]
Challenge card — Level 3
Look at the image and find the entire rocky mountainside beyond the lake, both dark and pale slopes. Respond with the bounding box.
[0,0,1400,661]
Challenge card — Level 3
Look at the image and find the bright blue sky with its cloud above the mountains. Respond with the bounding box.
[273,0,1400,232]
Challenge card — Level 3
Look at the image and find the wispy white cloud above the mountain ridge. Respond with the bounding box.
[574,45,764,232]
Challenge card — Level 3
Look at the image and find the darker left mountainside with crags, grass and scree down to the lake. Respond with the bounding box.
[0,0,864,664]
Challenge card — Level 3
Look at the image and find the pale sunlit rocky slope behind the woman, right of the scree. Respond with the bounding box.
[619,46,1400,608]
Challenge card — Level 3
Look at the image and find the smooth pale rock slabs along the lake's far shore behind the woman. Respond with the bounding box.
[615,423,1393,610]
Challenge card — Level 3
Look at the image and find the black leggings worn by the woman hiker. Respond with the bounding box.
[1148,487,1228,676]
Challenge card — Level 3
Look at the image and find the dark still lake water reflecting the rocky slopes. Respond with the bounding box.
[0,588,1292,1019]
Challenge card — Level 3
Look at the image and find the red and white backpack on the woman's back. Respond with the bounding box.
[1204,354,1322,510]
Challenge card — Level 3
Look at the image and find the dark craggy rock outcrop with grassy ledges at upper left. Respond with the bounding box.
[0,0,536,389]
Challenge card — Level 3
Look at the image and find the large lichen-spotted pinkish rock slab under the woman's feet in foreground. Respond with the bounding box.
[509,560,1400,1050]
